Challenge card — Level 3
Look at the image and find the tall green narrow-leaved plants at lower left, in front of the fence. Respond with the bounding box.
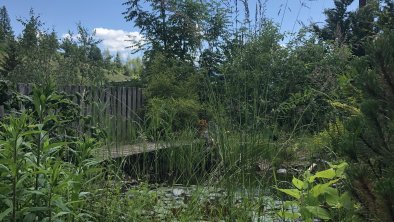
[0,83,102,221]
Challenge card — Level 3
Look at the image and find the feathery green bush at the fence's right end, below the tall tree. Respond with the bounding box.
[142,51,201,139]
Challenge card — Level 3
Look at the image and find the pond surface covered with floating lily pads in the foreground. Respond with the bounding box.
[125,182,292,222]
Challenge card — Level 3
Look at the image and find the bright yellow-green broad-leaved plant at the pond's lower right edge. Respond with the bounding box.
[277,162,357,221]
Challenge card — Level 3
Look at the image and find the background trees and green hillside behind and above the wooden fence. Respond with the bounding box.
[0,6,133,85]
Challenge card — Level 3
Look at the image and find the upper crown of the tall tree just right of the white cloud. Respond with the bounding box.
[123,0,206,63]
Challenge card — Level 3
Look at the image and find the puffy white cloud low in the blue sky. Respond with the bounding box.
[94,28,143,58]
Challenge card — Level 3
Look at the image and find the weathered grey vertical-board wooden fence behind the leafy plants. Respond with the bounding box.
[0,84,144,149]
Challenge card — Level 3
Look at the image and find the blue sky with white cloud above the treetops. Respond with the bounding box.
[0,0,358,58]
